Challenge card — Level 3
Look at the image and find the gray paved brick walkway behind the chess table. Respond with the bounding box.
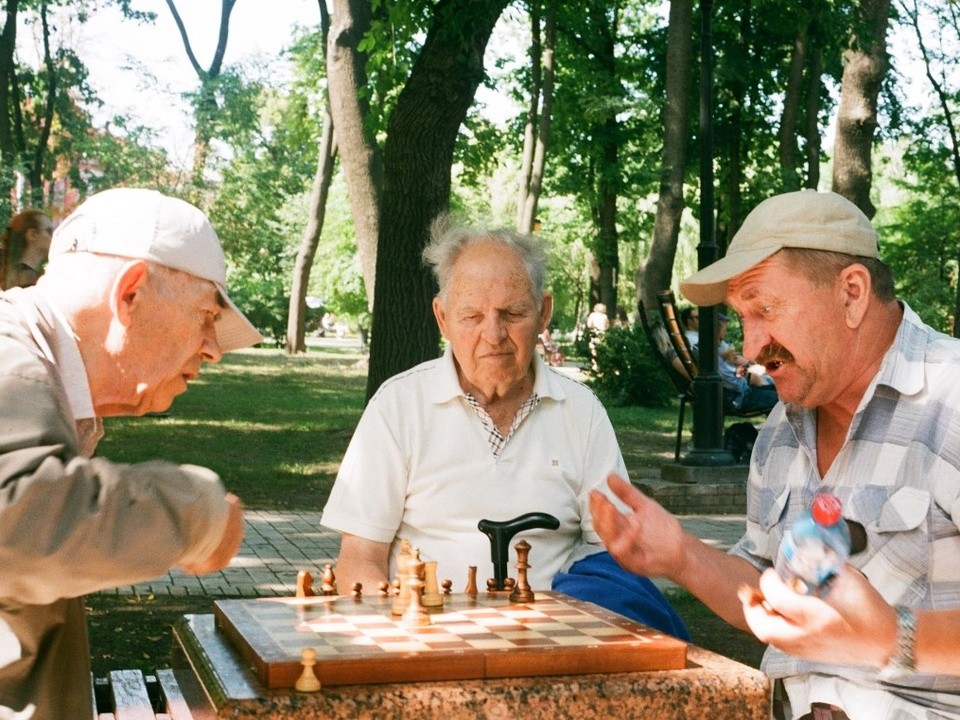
[101,510,745,597]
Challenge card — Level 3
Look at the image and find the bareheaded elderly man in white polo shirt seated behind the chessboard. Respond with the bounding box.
[322,217,686,636]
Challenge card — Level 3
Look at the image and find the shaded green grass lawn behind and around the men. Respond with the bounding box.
[86,348,762,677]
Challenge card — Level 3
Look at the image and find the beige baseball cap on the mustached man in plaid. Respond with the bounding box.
[680,190,880,306]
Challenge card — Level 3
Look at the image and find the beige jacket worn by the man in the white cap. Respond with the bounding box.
[0,288,227,720]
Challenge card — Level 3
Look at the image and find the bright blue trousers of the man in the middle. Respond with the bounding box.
[552,552,690,640]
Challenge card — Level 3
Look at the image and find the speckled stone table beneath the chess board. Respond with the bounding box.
[174,615,770,720]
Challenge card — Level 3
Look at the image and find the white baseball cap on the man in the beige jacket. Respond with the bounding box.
[50,188,263,352]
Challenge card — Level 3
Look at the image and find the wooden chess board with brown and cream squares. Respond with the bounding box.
[214,591,687,688]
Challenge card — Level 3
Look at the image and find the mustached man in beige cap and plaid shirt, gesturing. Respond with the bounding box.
[591,190,960,720]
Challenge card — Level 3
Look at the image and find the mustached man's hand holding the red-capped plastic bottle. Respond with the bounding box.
[738,565,897,667]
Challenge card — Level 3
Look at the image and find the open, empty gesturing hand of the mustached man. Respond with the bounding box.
[590,474,686,579]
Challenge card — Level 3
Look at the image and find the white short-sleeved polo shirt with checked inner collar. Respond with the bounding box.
[321,349,627,592]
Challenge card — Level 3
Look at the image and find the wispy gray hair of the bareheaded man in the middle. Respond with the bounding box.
[423,214,547,310]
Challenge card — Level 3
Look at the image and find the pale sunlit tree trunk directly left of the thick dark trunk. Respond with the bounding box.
[327,0,382,310]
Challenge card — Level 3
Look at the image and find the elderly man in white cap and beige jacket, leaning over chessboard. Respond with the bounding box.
[0,189,261,720]
